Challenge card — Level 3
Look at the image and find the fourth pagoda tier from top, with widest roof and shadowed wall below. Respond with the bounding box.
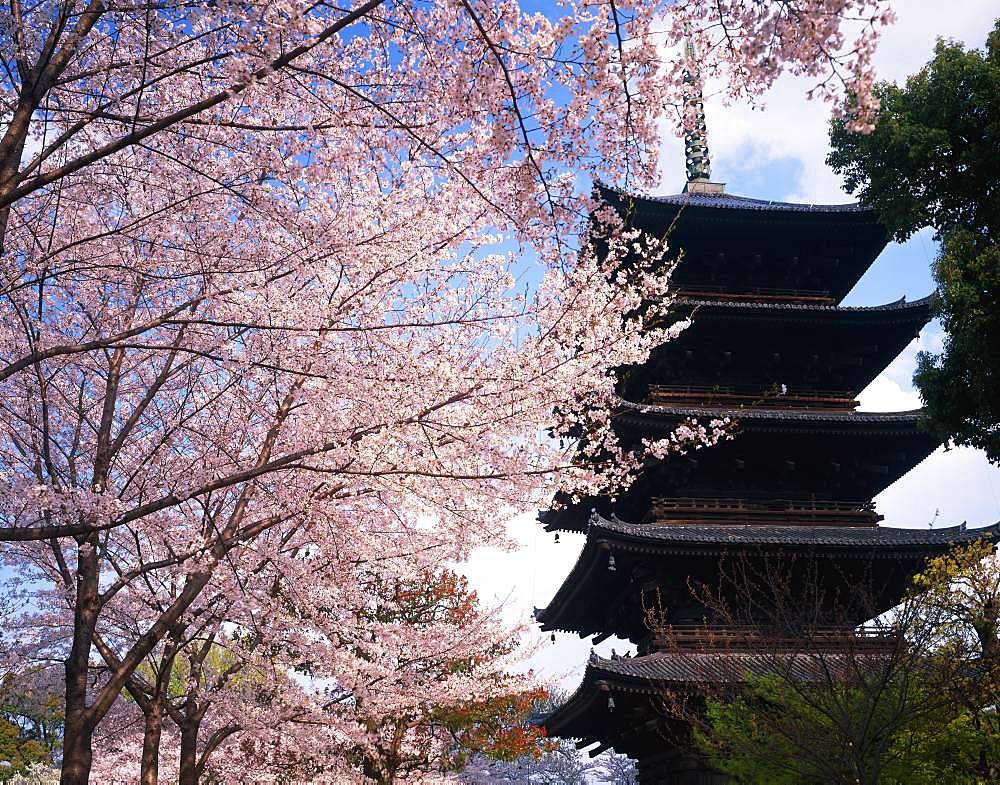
[535,514,1000,652]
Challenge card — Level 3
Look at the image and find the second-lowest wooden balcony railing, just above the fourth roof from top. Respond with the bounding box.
[647,497,883,527]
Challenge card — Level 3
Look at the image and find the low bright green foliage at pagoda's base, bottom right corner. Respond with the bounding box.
[695,664,1000,785]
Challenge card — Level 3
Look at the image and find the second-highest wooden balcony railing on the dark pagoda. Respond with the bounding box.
[647,384,859,412]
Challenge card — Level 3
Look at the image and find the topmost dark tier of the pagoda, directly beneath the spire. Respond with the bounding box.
[598,187,888,304]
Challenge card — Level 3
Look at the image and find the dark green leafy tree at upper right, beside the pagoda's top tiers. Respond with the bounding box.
[827,21,1000,462]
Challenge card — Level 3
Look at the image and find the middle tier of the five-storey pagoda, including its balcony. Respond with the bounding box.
[539,403,939,531]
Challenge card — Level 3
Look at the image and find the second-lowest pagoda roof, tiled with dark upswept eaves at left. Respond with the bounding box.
[535,512,1000,637]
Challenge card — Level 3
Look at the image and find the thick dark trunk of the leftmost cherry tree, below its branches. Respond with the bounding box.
[59,534,100,785]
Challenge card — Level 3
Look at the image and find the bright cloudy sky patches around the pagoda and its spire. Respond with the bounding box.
[467,0,1000,690]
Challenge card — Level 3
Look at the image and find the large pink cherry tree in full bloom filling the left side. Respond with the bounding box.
[0,0,900,785]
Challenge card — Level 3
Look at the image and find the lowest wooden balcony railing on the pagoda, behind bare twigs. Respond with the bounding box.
[639,624,899,654]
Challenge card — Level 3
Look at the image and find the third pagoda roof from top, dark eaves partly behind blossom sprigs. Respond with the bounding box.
[538,410,940,532]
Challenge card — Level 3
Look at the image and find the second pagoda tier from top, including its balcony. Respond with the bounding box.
[619,297,932,410]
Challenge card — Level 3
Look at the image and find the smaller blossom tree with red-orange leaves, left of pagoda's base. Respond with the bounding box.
[316,570,545,785]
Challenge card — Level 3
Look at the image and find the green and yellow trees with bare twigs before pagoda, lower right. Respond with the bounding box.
[695,541,1000,785]
